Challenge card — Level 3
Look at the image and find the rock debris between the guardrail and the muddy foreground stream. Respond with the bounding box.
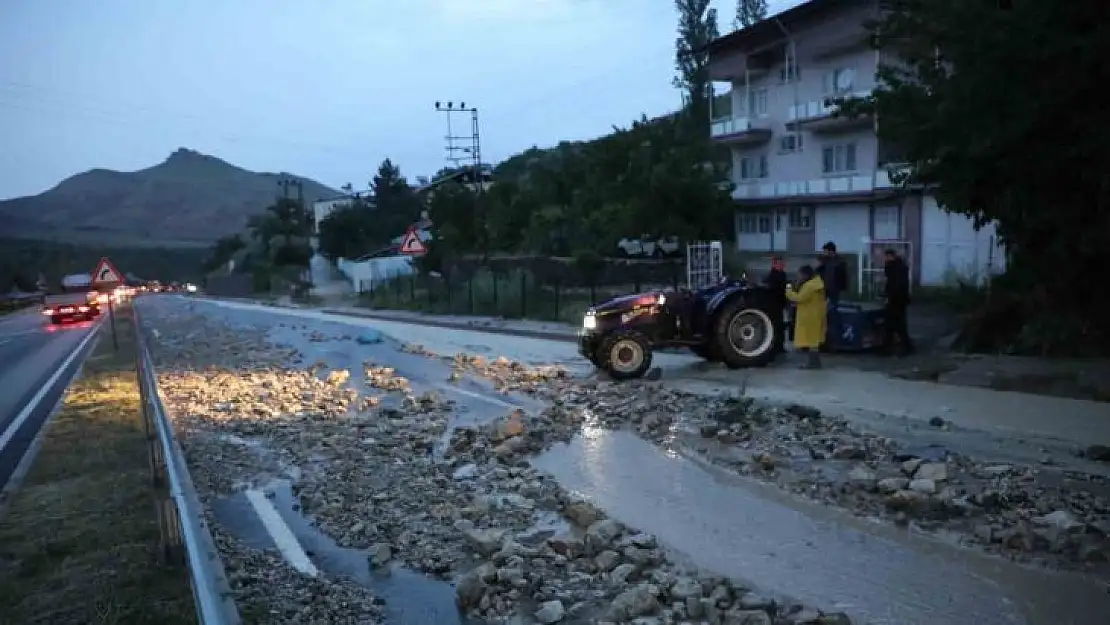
[138,299,849,625]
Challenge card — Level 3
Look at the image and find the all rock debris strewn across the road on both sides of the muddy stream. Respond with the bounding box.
[134,299,1110,625]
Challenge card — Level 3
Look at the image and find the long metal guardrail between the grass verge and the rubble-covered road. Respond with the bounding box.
[131,305,242,625]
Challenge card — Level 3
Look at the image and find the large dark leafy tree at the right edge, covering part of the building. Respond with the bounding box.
[856,0,1110,352]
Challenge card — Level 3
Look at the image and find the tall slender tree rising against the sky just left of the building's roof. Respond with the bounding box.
[674,0,719,132]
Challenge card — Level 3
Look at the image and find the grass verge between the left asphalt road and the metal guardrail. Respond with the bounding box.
[0,311,195,625]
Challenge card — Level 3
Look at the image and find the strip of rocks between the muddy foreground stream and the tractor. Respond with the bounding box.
[428,350,1110,574]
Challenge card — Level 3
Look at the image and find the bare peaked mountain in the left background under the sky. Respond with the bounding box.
[0,148,340,246]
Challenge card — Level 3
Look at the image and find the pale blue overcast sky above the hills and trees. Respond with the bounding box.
[0,0,798,198]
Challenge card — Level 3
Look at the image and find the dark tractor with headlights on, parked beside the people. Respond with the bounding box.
[578,279,783,380]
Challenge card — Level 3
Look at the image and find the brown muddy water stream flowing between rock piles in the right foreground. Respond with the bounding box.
[533,430,1110,625]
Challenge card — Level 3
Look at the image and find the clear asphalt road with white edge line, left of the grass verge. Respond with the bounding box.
[0,310,97,491]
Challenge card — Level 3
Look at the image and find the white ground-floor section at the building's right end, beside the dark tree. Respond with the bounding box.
[921,196,1005,286]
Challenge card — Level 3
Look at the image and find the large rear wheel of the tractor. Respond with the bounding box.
[713,293,778,369]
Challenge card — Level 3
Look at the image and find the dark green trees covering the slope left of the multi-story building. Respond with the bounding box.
[320,0,731,266]
